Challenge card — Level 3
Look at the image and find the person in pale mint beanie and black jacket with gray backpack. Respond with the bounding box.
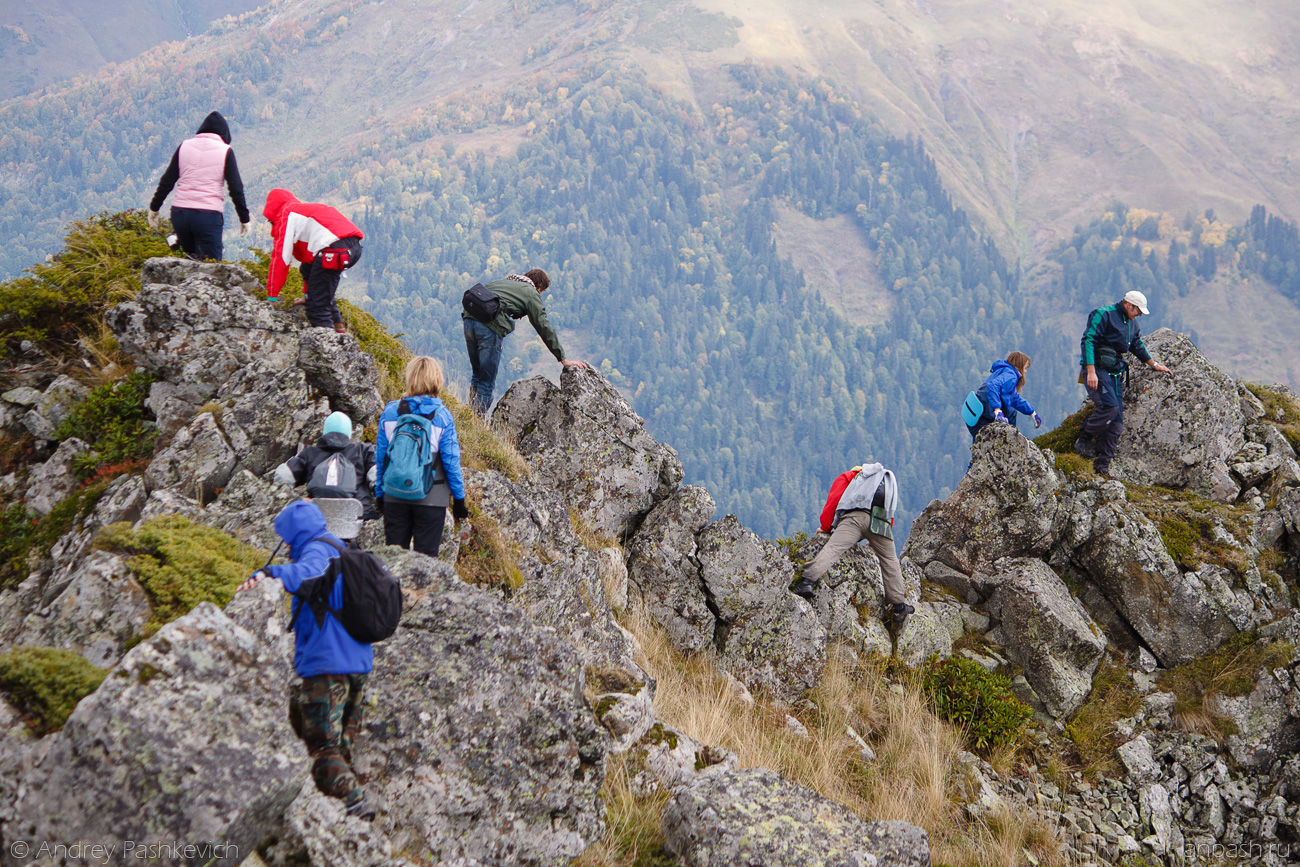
[274,412,380,521]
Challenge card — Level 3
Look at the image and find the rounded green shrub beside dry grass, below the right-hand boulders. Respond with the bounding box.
[920,656,1034,754]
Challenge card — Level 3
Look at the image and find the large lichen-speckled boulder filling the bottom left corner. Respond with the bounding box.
[0,603,311,866]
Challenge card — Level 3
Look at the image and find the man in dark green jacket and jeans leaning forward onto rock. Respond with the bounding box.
[460,268,586,416]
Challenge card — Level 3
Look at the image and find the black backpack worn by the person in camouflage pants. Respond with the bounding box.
[294,538,402,645]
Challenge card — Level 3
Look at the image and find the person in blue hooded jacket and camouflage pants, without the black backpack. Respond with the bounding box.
[239,500,374,819]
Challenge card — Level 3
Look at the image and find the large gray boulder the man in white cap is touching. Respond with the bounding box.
[1113,328,1245,500]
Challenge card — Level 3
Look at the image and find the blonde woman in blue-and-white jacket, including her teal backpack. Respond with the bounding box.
[374,355,469,556]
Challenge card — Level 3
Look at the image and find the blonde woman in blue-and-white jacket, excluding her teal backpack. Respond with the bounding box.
[374,355,469,556]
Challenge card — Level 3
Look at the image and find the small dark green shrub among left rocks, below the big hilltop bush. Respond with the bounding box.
[55,373,159,478]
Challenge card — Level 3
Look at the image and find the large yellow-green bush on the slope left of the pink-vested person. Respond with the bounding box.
[0,211,173,352]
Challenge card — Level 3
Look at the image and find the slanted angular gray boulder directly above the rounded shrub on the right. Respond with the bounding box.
[988,558,1106,718]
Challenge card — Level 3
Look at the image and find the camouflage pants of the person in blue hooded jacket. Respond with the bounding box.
[289,675,365,806]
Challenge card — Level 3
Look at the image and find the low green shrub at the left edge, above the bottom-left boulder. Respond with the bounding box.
[0,647,108,734]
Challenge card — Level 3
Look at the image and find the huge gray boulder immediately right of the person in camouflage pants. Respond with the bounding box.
[354,571,606,866]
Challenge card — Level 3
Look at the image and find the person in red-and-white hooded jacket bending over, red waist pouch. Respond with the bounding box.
[261,188,365,333]
